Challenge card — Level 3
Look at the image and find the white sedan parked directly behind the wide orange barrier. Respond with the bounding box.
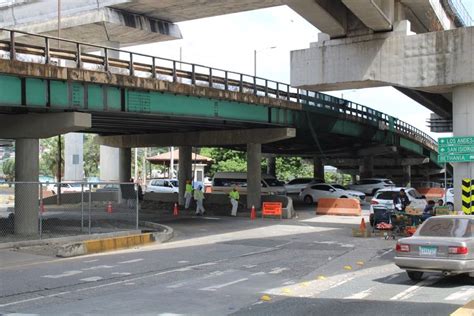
[299,183,365,204]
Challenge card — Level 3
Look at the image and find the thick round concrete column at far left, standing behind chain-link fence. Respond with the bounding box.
[14,139,39,235]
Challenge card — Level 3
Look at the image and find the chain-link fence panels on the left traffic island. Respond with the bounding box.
[0,182,142,243]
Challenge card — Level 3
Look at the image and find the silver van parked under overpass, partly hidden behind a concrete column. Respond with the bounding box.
[212,172,286,195]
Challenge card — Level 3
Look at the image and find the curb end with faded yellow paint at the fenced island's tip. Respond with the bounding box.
[56,222,174,258]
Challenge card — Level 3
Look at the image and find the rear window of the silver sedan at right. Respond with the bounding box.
[418,218,474,237]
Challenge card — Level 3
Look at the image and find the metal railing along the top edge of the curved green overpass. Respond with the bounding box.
[0,28,438,150]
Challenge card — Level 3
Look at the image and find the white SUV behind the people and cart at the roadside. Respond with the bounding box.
[369,187,427,225]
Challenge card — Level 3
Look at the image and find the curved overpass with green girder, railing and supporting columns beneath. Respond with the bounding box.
[0,31,442,233]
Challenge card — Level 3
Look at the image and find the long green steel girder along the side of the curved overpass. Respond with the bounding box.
[0,74,437,167]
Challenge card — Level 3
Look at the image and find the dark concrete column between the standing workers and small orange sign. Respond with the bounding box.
[247,144,262,209]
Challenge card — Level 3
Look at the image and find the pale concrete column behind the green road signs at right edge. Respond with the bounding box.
[453,85,474,210]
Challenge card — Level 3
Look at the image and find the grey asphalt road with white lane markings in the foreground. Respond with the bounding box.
[0,206,474,315]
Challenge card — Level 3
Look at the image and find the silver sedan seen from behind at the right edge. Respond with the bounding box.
[395,215,474,284]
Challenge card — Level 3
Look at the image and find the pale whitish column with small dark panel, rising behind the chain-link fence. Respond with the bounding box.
[64,133,84,181]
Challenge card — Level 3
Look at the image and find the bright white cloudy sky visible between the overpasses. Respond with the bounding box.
[129,0,474,138]
